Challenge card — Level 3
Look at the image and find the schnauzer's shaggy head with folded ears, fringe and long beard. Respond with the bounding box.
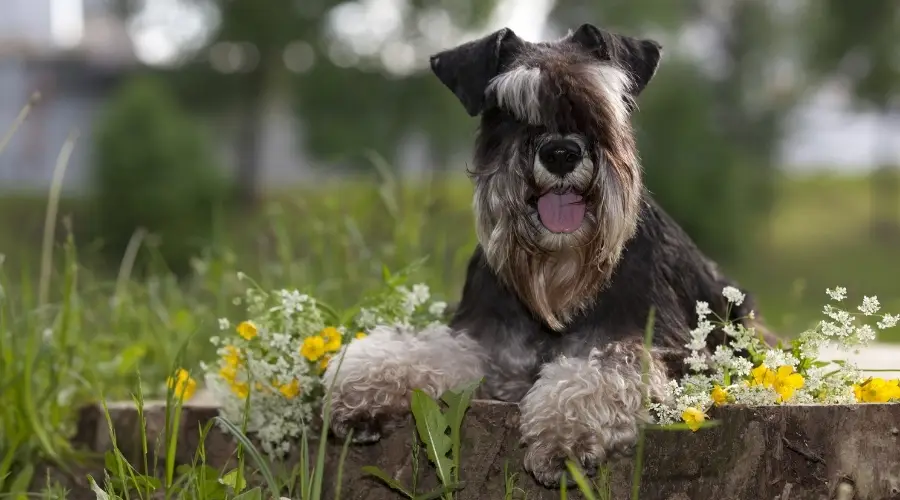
[431,24,661,329]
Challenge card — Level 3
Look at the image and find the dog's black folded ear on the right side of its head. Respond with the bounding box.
[571,24,662,97]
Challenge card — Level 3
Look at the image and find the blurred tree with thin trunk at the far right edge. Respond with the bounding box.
[815,0,900,243]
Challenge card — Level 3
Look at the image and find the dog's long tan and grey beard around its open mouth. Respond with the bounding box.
[474,139,641,330]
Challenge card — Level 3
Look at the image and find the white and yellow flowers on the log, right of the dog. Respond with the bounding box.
[648,287,900,424]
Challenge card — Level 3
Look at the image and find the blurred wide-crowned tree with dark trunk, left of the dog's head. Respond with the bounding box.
[112,0,496,204]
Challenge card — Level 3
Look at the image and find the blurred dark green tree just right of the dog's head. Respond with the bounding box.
[551,0,808,263]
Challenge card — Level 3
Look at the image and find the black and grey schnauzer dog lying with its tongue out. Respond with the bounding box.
[325,24,761,486]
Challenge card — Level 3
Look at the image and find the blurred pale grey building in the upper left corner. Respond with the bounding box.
[0,0,135,189]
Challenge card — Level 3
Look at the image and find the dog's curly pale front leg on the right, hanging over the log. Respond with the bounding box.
[520,343,667,486]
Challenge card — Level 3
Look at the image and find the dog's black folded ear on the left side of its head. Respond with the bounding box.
[430,28,525,116]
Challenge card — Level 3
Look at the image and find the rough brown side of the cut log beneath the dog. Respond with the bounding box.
[72,401,900,500]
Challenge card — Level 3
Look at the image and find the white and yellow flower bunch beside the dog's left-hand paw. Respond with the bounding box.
[202,275,447,458]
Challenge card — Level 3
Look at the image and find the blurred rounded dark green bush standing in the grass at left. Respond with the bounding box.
[93,77,227,273]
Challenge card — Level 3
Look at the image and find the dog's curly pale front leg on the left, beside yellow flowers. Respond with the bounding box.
[323,326,483,443]
